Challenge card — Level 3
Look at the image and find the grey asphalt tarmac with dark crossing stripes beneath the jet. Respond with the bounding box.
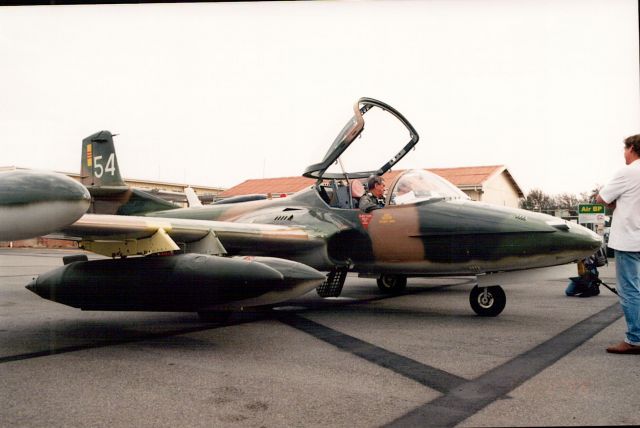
[0,249,640,427]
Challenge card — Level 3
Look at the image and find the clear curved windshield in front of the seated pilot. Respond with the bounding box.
[389,169,469,205]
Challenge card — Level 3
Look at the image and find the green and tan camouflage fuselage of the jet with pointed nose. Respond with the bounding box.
[147,184,600,275]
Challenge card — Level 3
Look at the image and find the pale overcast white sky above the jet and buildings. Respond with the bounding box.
[0,0,640,194]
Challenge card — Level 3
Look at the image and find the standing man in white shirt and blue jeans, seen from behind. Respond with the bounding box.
[596,134,640,354]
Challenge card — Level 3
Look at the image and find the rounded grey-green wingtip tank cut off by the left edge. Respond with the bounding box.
[0,170,91,241]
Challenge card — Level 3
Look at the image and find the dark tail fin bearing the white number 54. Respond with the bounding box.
[80,131,128,190]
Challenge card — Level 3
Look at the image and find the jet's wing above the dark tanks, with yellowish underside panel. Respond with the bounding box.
[48,214,327,262]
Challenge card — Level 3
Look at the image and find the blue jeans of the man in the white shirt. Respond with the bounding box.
[616,250,640,345]
